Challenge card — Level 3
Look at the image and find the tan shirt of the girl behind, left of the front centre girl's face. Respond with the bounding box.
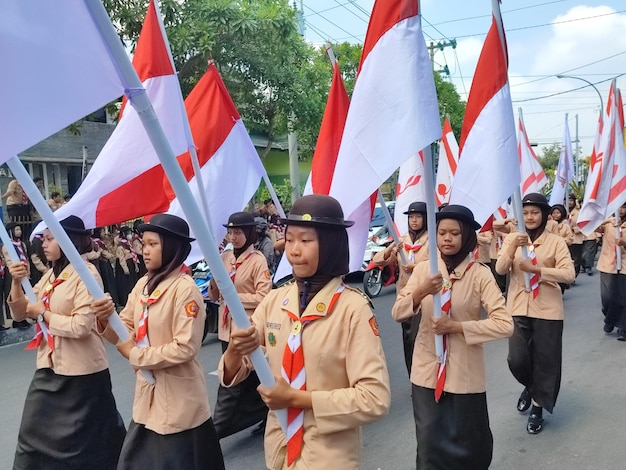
[209,245,272,341]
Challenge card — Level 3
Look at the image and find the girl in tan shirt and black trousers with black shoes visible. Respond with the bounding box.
[496,193,575,434]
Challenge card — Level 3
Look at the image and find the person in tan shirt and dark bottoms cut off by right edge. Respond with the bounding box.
[596,203,626,341]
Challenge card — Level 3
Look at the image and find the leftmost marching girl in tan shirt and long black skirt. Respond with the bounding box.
[9,216,125,470]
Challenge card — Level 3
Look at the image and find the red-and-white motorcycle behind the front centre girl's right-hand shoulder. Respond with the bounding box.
[363,226,398,298]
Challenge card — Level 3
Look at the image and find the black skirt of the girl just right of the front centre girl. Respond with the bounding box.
[413,384,493,470]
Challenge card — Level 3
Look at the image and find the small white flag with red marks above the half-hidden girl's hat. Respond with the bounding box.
[393,152,424,235]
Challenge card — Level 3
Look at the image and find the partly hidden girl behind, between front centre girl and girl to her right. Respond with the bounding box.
[373,202,428,375]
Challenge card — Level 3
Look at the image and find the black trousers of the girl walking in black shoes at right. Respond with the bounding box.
[508,316,563,413]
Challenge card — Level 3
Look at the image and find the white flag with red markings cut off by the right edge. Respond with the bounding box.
[578,80,626,235]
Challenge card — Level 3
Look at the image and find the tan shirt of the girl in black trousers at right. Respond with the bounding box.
[496,230,576,320]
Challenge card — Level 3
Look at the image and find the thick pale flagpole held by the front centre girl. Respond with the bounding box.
[84,0,287,431]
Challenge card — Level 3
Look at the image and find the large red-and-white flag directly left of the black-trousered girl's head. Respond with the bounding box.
[450,1,521,225]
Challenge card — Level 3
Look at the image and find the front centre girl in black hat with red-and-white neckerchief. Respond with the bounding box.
[218,195,391,470]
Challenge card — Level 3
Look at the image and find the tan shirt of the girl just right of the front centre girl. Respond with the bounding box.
[391,259,513,392]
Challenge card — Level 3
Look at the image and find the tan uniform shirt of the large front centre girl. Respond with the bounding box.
[218,278,391,470]
